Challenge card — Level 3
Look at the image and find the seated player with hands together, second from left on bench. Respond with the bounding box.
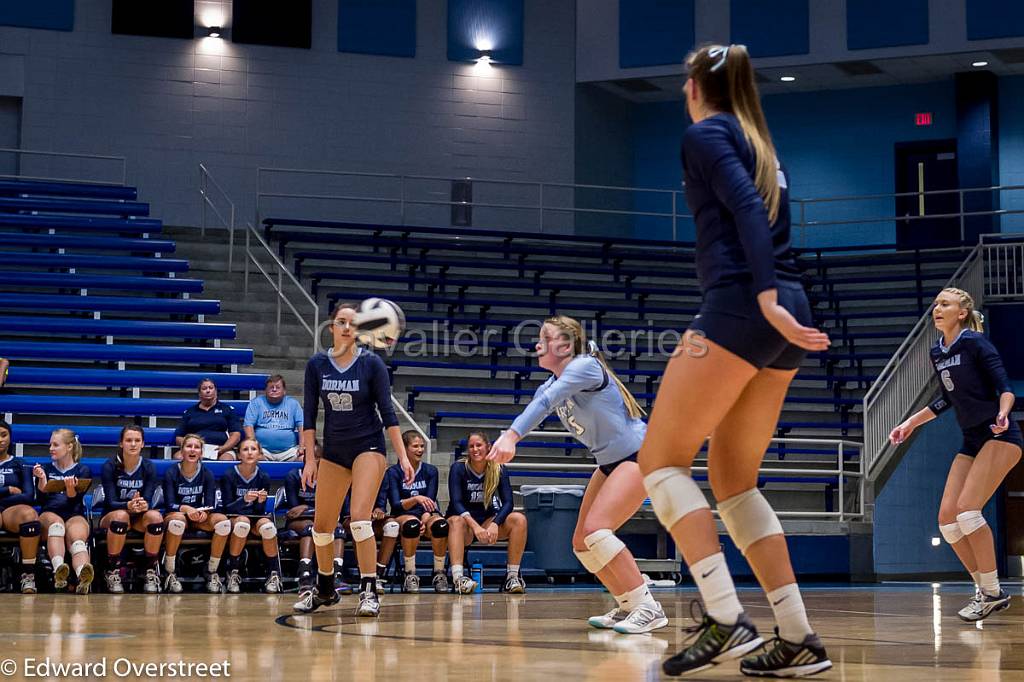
[32,429,95,594]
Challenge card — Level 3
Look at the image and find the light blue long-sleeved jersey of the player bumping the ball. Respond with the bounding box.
[512,355,647,466]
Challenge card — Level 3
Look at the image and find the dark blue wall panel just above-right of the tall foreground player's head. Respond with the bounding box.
[729,0,810,56]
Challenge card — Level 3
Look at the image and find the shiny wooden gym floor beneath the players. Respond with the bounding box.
[0,584,1024,682]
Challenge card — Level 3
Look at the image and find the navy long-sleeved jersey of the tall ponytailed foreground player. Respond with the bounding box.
[682,114,800,295]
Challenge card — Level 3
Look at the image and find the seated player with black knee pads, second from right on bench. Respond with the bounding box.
[384,429,452,594]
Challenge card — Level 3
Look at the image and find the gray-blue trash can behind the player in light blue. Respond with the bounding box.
[519,485,586,572]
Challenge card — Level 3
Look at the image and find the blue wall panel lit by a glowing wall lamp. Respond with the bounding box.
[447,0,524,65]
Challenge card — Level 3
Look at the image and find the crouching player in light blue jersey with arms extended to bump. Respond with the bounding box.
[487,315,669,634]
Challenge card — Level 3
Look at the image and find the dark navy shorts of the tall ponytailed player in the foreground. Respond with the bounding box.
[690,281,814,370]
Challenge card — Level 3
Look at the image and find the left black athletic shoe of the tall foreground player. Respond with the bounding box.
[662,601,764,676]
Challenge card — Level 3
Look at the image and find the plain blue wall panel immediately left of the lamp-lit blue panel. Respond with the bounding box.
[338,0,416,57]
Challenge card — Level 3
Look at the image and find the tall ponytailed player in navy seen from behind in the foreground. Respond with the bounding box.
[639,45,831,677]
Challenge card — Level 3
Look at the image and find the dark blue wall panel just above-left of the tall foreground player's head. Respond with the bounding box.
[618,0,693,69]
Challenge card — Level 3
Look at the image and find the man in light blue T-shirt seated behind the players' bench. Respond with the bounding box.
[243,374,302,462]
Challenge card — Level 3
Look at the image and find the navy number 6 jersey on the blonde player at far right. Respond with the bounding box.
[929,329,1014,429]
